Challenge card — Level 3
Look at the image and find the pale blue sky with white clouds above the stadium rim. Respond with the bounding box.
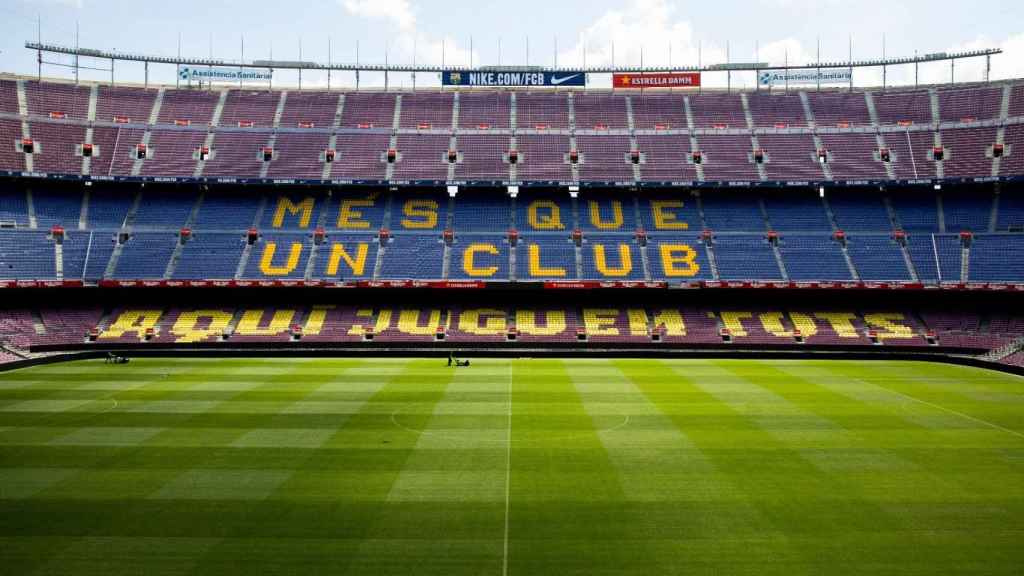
[0,0,1024,87]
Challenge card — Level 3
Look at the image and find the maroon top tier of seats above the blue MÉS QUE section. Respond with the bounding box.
[0,81,1024,184]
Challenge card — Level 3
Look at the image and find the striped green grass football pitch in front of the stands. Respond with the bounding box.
[0,359,1024,576]
